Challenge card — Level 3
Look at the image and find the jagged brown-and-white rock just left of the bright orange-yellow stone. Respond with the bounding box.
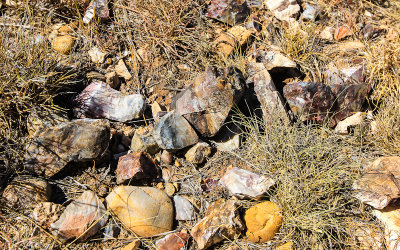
[190,199,244,249]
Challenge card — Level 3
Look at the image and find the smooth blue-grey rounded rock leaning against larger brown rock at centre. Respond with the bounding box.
[152,111,199,149]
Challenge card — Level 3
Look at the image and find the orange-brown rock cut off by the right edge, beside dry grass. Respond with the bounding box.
[353,156,400,209]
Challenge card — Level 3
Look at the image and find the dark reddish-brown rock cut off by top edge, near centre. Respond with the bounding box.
[206,0,250,25]
